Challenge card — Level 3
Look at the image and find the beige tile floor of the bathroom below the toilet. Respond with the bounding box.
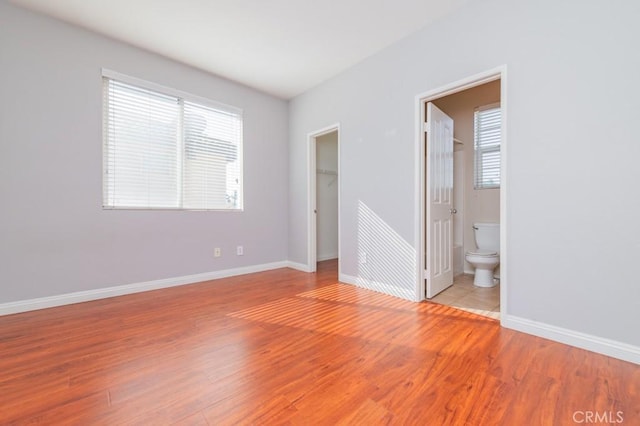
[431,274,500,319]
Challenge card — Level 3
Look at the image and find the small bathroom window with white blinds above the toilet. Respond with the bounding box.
[473,104,502,189]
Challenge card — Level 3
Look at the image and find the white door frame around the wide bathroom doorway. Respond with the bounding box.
[415,65,509,321]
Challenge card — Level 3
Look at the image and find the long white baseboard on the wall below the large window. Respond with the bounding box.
[0,261,291,315]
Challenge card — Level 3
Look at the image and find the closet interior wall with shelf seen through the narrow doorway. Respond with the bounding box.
[316,131,338,261]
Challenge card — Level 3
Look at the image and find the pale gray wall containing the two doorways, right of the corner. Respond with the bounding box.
[289,0,640,345]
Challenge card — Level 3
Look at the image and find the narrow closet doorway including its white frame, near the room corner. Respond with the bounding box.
[307,124,340,273]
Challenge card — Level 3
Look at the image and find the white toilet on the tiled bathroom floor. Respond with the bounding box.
[465,223,500,287]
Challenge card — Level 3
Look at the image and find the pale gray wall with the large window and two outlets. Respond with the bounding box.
[0,2,288,304]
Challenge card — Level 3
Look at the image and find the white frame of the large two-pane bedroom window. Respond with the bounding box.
[100,68,244,212]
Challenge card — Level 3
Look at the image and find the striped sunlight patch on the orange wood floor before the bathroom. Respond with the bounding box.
[228,283,493,348]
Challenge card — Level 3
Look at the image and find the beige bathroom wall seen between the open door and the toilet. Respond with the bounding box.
[433,81,500,273]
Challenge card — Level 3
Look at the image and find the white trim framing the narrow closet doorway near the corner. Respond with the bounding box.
[307,123,342,276]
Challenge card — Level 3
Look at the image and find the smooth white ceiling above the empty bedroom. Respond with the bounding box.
[11,0,468,99]
